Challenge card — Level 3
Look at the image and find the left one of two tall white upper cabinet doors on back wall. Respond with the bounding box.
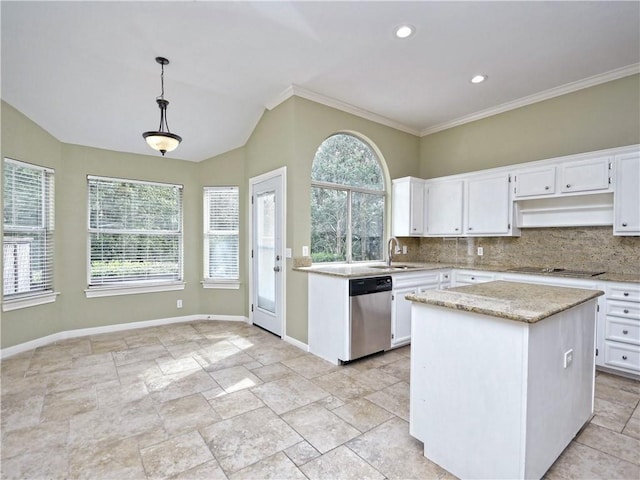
[426,180,464,235]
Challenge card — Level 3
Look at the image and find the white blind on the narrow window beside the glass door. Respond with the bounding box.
[204,187,240,281]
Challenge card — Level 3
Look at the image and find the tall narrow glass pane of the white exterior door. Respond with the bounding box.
[254,191,276,313]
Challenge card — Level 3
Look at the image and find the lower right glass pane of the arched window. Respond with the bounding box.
[351,192,384,262]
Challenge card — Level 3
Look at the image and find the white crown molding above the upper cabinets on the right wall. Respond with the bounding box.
[420,63,640,137]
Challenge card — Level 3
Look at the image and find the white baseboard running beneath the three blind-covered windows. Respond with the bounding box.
[0,314,249,359]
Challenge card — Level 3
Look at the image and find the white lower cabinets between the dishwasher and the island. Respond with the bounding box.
[391,271,450,348]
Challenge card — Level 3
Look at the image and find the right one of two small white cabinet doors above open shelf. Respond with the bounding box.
[560,157,611,193]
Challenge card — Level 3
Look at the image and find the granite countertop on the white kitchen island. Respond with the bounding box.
[406,281,604,323]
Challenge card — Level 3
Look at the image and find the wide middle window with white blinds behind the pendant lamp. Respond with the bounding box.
[88,176,183,287]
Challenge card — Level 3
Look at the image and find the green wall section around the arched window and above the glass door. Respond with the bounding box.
[246,97,419,343]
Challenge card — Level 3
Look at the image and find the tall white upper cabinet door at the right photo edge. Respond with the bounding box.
[613,152,640,235]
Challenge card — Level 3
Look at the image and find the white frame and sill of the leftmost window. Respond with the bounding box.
[2,157,59,312]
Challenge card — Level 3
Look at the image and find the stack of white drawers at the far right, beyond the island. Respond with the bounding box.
[603,283,640,375]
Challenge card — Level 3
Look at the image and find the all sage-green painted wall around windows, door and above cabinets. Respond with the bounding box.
[0,75,640,348]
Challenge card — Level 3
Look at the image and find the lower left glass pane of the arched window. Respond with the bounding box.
[311,187,348,262]
